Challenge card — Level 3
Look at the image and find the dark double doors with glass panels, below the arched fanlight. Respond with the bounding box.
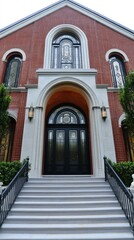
[45,126,89,174]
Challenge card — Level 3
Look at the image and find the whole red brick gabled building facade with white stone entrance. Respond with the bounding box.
[0,0,134,176]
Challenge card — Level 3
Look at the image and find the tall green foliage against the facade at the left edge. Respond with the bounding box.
[0,84,11,149]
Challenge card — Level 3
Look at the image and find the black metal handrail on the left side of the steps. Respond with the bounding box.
[0,158,29,226]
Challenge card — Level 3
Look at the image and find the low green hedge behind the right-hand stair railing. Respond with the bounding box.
[111,162,134,187]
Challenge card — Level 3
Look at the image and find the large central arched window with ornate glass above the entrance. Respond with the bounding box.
[52,33,81,69]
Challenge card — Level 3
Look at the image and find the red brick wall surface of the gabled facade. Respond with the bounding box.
[0,7,134,161]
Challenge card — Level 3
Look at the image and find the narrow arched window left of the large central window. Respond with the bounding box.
[4,54,22,87]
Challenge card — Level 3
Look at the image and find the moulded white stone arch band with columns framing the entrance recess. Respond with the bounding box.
[31,78,104,177]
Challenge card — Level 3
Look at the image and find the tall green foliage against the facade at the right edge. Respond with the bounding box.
[119,71,134,136]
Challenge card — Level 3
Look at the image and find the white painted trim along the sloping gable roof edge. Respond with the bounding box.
[0,0,134,39]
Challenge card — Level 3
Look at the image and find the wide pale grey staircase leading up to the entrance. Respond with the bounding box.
[0,175,134,240]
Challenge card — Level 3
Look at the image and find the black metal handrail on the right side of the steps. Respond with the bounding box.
[104,157,134,234]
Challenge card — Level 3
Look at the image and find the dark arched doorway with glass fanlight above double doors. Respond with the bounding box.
[45,105,89,174]
